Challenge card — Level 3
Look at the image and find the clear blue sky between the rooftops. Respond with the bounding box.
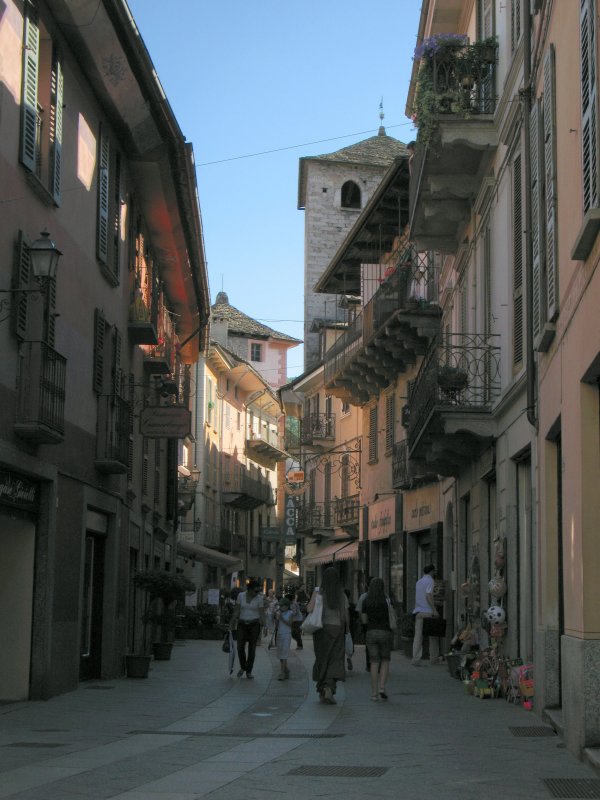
[128,0,421,376]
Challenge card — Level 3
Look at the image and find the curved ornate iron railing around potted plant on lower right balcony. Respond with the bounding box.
[408,333,500,450]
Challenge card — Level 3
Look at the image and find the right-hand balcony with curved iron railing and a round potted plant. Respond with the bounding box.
[407,333,500,476]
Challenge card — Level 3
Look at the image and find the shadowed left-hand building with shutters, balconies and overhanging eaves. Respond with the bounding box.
[0,0,209,700]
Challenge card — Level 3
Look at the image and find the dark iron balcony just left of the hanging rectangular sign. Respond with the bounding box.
[94,394,130,475]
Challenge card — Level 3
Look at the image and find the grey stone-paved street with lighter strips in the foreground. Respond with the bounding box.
[0,639,600,800]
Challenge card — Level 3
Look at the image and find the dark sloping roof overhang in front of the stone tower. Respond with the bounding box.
[314,157,409,295]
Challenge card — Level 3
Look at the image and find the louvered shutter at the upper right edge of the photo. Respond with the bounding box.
[580,0,600,214]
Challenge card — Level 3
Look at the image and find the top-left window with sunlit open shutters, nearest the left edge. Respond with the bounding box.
[20,2,64,205]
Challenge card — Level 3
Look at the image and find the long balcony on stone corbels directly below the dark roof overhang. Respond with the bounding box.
[324,245,441,405]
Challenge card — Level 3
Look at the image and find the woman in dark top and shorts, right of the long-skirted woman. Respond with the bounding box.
[362,578,393,701]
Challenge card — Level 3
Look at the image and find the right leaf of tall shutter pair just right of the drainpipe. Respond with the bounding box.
[544,44,558,321]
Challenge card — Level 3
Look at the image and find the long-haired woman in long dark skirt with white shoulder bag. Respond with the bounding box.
[307,567,349,704]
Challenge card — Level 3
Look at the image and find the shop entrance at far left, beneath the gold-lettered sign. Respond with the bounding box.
[0,513,35,700]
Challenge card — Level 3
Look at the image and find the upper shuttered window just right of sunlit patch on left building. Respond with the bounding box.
[96,126,121,284]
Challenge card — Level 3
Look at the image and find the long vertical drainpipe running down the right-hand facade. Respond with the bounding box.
[520,2,537,428]
